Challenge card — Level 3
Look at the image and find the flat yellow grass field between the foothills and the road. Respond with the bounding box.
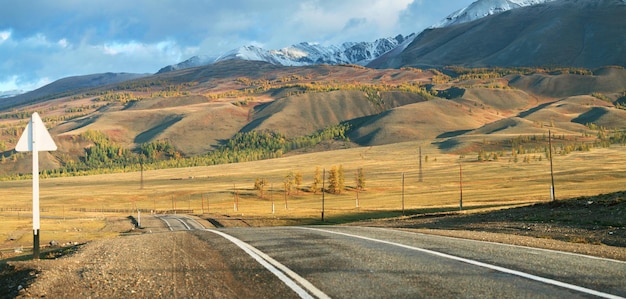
[0,142,626,250]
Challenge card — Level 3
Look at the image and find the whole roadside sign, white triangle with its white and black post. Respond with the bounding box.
[15,112,57,260]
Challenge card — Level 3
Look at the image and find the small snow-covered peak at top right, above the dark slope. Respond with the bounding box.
[430,0,554,28]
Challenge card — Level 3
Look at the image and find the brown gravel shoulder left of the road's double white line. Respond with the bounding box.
[1,217,291,298]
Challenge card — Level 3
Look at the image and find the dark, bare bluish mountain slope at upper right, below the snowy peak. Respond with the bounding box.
[368,0,626,68]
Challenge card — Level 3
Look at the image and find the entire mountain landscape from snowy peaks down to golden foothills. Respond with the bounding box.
[0,0,626,175]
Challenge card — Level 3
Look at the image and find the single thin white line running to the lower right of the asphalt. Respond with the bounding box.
[294,227,624,299]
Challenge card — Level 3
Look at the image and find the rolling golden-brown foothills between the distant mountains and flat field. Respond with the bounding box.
[0,60,626,175]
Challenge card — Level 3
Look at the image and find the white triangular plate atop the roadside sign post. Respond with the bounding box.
[15,112,57,152]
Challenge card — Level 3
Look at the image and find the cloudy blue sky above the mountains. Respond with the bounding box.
[0,0,474,92]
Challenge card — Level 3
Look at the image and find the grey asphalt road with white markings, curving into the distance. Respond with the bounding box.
[161,215,626,298]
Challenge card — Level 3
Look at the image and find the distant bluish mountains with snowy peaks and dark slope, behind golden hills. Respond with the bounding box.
[0,0,626,108]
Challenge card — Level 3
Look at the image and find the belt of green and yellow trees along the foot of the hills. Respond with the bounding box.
[5,124,350,179]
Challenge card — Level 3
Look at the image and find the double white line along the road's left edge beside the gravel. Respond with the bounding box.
[204,229,330,299]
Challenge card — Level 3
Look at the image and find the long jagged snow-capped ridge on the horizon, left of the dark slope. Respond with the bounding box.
[159,35,413,73]
